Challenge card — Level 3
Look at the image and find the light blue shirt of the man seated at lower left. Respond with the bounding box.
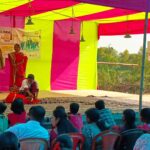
[6,120,50,141]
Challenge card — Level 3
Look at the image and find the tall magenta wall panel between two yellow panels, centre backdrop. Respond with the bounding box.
[51,21,80,90]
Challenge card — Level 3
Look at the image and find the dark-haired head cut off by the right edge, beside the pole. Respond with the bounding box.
[140,108,150,124]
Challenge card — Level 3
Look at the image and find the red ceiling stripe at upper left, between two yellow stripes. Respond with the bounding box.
[2,0,78,16]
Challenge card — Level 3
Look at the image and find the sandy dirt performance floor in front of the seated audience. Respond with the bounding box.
[0,90,150,116]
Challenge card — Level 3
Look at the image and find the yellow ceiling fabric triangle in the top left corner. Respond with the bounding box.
[0,0,29,12]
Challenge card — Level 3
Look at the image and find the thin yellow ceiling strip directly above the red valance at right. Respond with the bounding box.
[95,12,150,23]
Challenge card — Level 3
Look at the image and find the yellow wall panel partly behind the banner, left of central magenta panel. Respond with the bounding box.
[25,19,53,90]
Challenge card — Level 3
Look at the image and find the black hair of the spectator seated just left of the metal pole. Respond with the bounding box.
[123,109,136,129]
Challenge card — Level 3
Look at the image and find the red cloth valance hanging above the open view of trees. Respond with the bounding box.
[98,20,150,36]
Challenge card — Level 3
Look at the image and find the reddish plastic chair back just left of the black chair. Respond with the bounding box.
[92,130,120,150]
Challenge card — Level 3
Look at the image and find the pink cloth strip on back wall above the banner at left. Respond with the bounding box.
[0,14,25,28]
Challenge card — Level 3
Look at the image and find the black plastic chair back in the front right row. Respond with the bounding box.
[115,129,144,150]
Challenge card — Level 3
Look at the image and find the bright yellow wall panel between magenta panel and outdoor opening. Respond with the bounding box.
[77,22,98,90]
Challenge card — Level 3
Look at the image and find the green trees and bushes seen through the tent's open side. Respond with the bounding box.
[97,47,150,93]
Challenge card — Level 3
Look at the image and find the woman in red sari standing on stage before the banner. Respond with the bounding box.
[8,44,28,88]
